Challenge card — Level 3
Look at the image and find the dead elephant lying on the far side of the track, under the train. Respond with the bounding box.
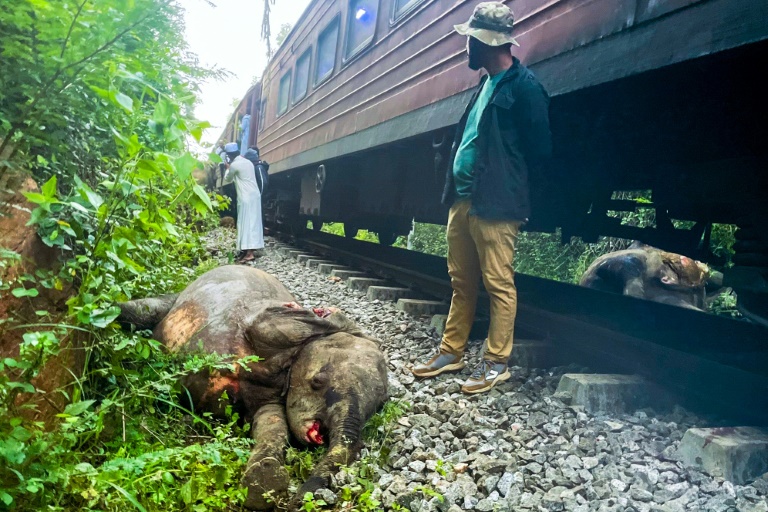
[579,242,722,311]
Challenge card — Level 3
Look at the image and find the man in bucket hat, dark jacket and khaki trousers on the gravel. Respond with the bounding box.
[412,2,552,393]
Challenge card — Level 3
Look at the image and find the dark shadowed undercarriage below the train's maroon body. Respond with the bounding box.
[260,41,768,311]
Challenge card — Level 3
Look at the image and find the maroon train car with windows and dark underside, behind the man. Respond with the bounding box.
[219,0,768,284]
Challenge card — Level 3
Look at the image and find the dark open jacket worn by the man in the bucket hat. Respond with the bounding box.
[443,58,552,221]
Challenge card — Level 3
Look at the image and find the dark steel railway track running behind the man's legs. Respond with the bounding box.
[278,232,768,425]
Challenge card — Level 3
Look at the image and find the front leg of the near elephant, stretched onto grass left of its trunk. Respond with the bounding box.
[242,404,290,510]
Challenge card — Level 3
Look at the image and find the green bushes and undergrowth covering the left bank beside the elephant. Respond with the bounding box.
[0,0,250,511]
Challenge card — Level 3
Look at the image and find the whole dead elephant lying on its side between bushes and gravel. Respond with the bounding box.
[119,265,387,510]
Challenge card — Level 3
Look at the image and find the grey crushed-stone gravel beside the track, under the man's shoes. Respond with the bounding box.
[200,228,768,512]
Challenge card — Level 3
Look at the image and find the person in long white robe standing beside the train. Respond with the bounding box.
[224,142,264,263]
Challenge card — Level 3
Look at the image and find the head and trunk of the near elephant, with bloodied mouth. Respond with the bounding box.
[286,332,387,497]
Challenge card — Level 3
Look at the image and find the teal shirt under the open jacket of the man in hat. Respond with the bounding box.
[453,73,504,199]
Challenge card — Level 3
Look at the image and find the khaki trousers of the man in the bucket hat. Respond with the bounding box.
[440,199,521,363]
